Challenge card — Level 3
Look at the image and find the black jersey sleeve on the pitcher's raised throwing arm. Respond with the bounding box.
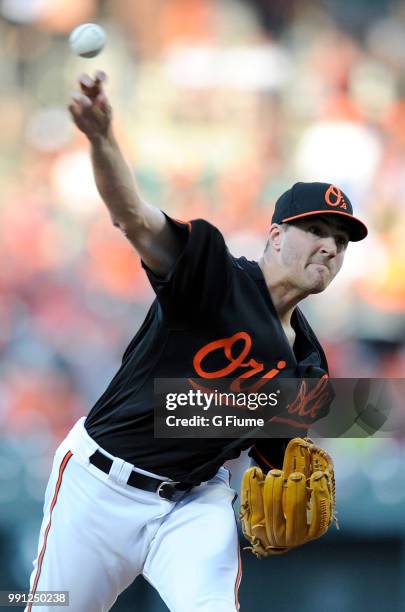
[142,216,233,321]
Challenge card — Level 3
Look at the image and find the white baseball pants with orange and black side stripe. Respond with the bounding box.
[25,417,241,612]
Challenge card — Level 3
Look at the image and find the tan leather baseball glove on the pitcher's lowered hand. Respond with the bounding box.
[240,438,338,558]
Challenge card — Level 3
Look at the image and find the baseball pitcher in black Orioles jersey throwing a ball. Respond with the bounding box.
[26,72,367,612]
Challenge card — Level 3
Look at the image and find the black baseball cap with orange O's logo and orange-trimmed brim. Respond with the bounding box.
[271,183,368,242]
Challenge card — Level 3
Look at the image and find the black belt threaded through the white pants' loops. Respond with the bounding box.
[90,450,193,501]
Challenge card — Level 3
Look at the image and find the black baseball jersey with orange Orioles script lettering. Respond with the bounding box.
[85,217,328,483]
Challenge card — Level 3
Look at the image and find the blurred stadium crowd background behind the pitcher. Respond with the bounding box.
[0,0,405,612]
